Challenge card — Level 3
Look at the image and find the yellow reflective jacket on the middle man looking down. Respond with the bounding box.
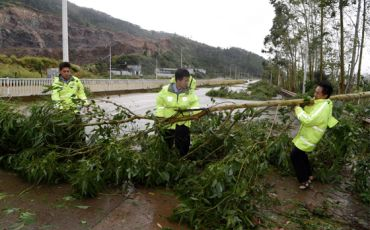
[156,83,199,129]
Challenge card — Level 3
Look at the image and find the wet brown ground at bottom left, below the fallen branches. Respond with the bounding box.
[0,170,186,230]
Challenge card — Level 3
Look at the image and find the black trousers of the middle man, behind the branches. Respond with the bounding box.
[164,125,190,156]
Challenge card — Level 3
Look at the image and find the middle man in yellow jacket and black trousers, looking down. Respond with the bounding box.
[156,69,199,156]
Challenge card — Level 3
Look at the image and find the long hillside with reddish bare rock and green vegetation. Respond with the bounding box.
[0,0,264,77]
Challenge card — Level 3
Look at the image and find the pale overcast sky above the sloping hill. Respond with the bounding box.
[69,0,370,73]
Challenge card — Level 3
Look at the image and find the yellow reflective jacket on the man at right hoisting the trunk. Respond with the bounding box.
[293,99,338,152]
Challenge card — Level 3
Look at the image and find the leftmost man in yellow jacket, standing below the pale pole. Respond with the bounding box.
[51,62,87,109]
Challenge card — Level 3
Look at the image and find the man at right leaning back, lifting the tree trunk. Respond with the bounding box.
[290,81,338,189]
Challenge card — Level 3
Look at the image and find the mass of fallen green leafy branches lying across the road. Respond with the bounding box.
[0,98,369,229]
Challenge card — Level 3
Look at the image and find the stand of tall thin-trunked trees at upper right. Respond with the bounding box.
[265,0,369,93]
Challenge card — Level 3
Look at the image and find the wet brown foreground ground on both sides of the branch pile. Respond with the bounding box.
[0,167,370,230]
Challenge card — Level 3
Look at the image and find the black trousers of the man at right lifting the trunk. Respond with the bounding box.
[290,146,312,183]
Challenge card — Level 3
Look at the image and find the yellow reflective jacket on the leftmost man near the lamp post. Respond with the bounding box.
[51,76,87,109]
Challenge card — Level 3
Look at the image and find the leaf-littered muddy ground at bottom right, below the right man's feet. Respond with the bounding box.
[266,170,370,230]
